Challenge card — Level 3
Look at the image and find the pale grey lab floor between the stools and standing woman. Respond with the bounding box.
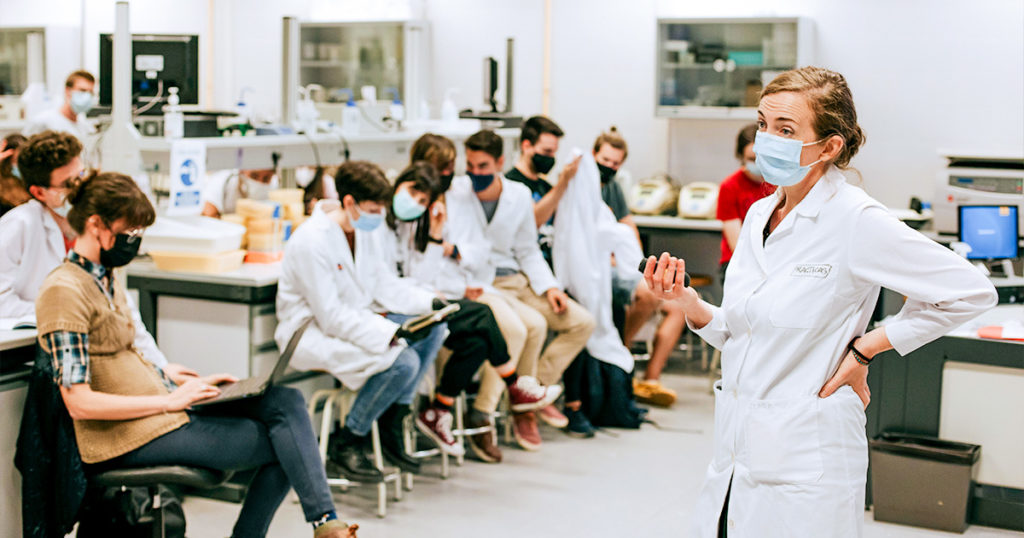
[184,361,1021,538]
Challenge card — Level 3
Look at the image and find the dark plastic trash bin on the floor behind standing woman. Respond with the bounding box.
[870,432,981,533]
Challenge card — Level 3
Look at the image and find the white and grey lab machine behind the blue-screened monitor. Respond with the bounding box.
[933,152,1024,235]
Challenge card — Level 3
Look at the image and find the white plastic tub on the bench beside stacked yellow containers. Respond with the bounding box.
[141,216,246,254]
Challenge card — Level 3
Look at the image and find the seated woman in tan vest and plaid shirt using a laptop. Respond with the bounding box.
[36,173,356,538]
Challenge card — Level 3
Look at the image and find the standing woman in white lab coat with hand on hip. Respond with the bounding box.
[644,68,996,538]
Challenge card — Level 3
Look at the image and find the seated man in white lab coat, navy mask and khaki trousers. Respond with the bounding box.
[445,130,594,450]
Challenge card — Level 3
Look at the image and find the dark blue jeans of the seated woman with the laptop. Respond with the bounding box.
[111,386,334,537]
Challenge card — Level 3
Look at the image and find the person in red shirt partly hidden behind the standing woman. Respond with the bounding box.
[715,123,775,283]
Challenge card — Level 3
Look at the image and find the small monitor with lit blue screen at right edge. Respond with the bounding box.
[959,206,1020,259]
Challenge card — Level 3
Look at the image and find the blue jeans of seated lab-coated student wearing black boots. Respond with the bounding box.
[345,314,447,436]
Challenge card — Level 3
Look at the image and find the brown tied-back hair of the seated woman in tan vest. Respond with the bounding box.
[68,171,157,234]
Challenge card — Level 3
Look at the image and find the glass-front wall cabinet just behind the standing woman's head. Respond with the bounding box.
[655,17,813,119]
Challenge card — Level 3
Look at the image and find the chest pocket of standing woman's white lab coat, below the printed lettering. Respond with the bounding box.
[768,264,837,329]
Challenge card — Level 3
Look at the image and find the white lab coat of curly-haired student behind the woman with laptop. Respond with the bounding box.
[0,200,167,368]
